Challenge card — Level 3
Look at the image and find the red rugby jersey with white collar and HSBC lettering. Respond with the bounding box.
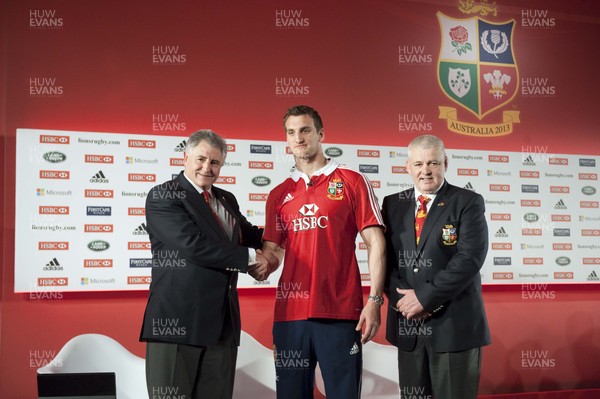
[263,160,383,321]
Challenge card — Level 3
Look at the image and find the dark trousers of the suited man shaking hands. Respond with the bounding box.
[146,334,238,399]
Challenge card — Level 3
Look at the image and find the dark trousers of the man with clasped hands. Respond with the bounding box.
[398,335,481,399]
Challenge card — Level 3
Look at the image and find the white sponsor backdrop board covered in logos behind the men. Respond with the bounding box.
[15,129,600,292]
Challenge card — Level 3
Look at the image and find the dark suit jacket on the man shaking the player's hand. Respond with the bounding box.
[140,172,262,346]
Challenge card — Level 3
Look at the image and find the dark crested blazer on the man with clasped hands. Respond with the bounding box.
[382,182,490,352]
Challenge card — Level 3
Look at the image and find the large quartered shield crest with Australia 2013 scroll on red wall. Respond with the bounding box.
[437,7,519,137]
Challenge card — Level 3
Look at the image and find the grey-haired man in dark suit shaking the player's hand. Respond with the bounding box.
[140,130,265,399]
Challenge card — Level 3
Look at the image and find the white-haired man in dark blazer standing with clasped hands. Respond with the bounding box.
[382,135,490,399]
